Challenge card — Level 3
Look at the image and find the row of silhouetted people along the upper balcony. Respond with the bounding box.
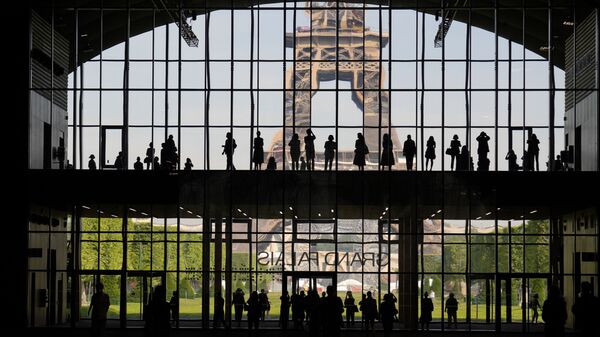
[88,129,565,171]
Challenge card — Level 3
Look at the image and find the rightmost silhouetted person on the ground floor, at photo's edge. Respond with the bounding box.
[571,281,600,336]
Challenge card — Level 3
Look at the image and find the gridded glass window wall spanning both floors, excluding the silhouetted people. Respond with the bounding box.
[29,1,598,331]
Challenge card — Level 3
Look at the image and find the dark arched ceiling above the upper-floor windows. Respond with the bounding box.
[33,0,600,71]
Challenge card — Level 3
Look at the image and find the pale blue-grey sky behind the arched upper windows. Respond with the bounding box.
[69,4,564,170]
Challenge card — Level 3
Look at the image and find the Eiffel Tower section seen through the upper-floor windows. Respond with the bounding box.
[270,1,402,170]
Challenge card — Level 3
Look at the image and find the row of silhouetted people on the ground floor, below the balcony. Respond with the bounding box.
[88,281,600,337]
